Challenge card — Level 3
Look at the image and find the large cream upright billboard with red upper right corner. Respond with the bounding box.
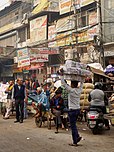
[30,16,47,43]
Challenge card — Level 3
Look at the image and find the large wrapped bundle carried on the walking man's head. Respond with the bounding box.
[62,60,92,82]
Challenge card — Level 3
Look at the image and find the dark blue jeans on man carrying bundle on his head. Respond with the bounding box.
[68,109,80,144]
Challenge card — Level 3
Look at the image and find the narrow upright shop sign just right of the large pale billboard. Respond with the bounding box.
[48,25,57,47]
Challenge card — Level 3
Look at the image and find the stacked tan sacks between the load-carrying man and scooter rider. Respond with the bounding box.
[80,83,94,110]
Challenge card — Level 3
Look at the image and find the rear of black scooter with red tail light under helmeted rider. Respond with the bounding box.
[87,108,104,134]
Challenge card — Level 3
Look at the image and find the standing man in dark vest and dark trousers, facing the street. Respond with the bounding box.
[13,78,26,123]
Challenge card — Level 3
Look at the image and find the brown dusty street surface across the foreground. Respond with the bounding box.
[0,115,114,152]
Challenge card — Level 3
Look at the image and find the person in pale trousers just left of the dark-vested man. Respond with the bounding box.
[3,81,14,119]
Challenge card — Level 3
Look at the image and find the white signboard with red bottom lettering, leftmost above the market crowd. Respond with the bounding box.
[17,48,30,67]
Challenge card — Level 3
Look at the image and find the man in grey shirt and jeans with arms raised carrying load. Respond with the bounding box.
[61,70,83,146]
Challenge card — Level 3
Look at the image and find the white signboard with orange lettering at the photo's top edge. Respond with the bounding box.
[59,0,72,15]
